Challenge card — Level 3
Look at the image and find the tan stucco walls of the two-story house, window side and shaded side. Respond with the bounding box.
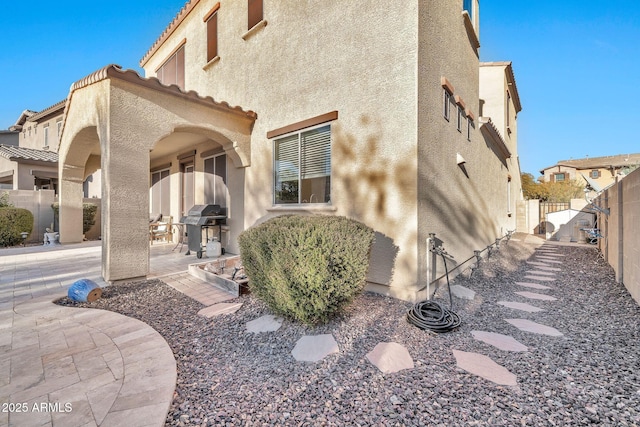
[138,0,520,299]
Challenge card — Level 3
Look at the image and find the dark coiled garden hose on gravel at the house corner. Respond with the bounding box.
[407,249,461,333]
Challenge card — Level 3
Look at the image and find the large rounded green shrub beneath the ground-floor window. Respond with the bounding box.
[238,215,374,324]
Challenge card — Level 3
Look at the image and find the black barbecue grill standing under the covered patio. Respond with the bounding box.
[180,205,227,258]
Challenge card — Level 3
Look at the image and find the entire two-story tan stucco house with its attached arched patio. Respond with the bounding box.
[60,0,521,299]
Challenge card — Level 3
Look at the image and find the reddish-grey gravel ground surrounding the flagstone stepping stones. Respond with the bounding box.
[59,239,640,426]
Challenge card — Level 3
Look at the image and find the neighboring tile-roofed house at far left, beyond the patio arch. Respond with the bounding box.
[0,99,100,197]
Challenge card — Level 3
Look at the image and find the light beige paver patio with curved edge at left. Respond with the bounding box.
[0,242,235,427]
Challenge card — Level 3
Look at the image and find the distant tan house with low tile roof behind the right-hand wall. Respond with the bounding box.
[540,153,640,192]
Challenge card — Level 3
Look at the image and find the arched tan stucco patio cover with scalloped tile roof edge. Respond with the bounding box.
[59,65,256,282]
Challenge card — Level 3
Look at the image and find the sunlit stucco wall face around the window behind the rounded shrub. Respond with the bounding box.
[145,1,417,298]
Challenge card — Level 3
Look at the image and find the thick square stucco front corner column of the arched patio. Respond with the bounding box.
[102,123,150,282]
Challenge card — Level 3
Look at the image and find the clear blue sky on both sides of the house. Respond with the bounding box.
[0,0,640,176]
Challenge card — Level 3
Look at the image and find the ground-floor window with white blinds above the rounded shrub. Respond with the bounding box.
[274,125,331,204]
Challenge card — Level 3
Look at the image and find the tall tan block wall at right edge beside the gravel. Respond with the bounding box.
[595,169,640,304]
